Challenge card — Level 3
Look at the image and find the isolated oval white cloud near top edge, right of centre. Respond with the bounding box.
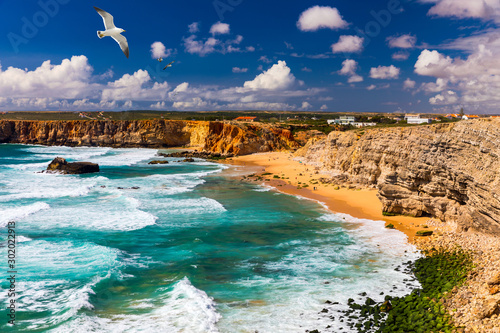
[297,6,349,31]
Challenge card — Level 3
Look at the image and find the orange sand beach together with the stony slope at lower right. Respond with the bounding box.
[221,152,500,333]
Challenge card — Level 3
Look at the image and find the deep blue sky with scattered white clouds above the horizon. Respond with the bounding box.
[0,0,500,114]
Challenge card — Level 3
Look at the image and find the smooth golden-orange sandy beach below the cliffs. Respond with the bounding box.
[225,152,433,242]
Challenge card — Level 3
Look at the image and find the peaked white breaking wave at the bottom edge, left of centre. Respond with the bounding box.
[50,278,221,333]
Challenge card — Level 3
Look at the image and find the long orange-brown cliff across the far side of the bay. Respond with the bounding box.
[0,120,298,155]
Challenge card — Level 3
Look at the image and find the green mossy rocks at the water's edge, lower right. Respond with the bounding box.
[338,249,473,333]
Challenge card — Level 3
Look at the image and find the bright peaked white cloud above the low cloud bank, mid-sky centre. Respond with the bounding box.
[243,60,295,90]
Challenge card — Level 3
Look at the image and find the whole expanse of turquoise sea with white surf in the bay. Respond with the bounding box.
[0,145,418,333]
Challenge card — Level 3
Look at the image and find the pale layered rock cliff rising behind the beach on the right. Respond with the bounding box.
[298,119,500,234]
